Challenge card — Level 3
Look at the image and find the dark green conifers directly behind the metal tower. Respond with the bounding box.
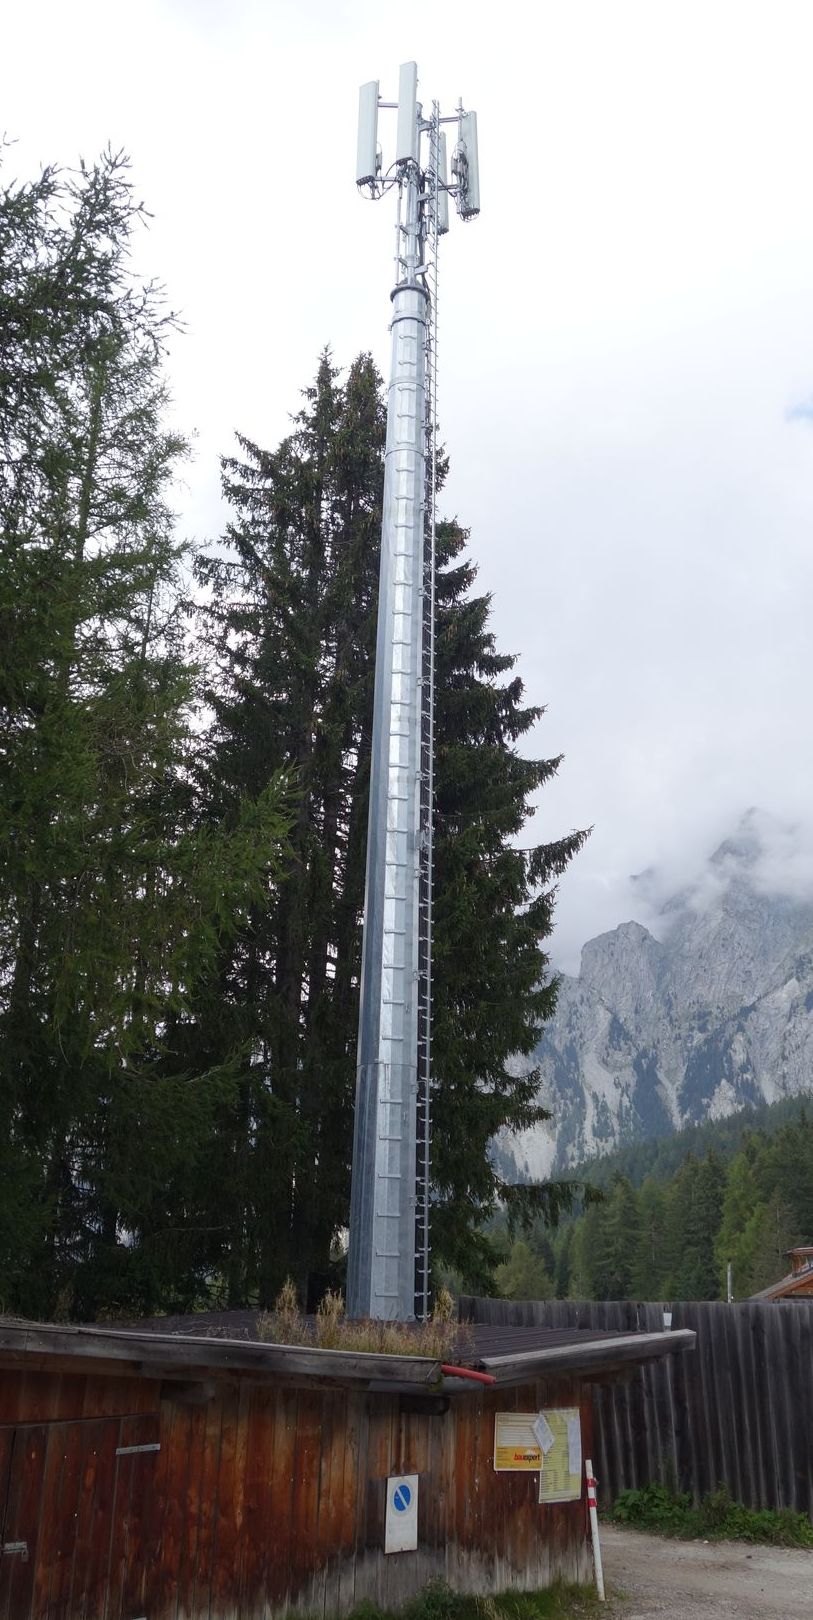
[186,355,581,1304]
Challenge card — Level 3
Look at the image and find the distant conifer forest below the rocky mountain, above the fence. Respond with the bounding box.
[496,1103,813,1299]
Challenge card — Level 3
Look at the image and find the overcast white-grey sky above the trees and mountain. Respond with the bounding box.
[0,0,813,967]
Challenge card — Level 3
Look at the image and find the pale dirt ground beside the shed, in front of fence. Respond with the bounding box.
[601,1526,813,1620]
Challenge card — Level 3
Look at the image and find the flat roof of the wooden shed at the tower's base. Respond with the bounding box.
[0,1312,695,1395]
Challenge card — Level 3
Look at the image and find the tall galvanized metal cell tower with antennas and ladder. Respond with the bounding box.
[347,62,479,1320]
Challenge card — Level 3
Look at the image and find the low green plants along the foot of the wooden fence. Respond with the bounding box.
[609,1484,813,1547]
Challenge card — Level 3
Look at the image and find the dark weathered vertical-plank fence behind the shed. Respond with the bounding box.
[462,1299,813,1516]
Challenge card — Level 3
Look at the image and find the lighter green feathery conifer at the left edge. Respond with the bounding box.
[0,152,283,1314]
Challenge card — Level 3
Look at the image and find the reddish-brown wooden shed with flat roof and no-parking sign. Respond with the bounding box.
[0,1312,693,1620]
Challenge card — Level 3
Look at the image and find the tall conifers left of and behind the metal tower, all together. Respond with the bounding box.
[0,152,586,1319]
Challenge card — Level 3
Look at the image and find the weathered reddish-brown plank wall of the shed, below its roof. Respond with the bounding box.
[0,1372,591,1620]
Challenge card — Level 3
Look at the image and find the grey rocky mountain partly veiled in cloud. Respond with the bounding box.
[497,812,813,1179]
